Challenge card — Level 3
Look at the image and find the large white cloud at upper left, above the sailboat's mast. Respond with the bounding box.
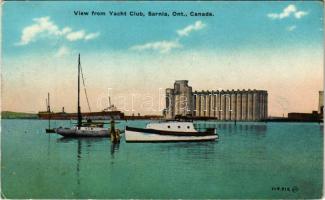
[16,16,99,45]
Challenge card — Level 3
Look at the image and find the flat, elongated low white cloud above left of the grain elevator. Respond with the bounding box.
[130,40,182,53]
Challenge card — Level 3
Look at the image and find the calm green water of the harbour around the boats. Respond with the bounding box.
[1,120,323,199]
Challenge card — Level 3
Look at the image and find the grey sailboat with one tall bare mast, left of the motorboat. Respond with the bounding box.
[55,54,111,137]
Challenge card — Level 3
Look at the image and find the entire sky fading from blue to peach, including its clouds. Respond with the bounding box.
[2,1,323,115]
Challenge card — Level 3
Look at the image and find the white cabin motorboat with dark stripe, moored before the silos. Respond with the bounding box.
[125,121,218,142]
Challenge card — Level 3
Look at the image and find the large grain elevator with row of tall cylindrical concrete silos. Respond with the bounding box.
[164,80,268,121]
